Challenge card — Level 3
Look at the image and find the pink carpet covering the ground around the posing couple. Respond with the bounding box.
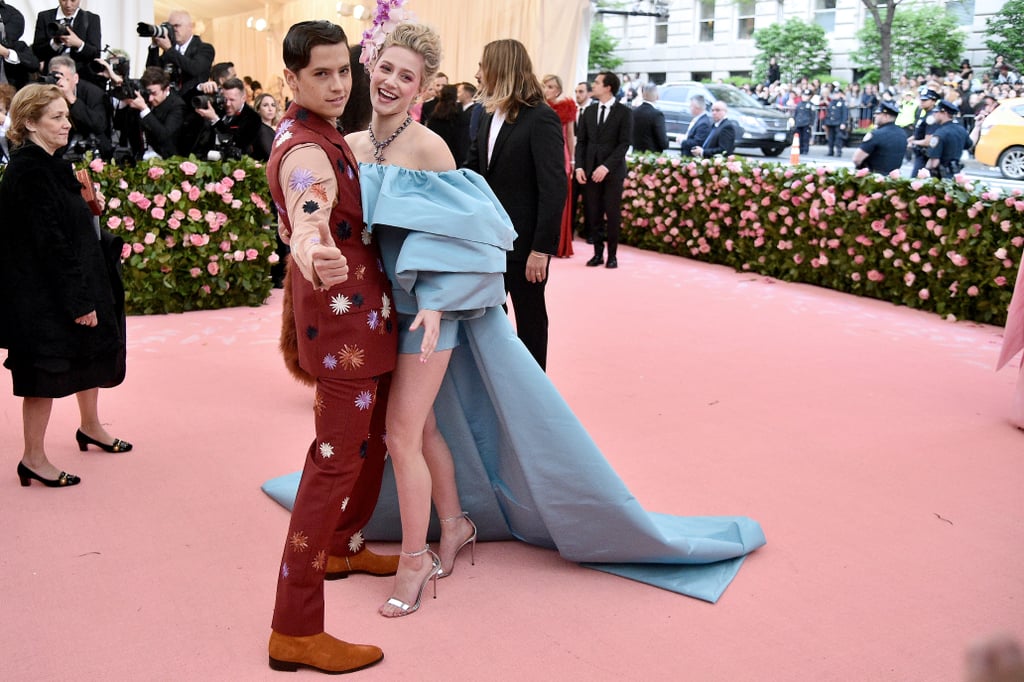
[0,242,1024,682]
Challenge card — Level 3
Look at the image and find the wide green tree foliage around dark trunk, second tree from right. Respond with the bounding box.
[851,0,966,85]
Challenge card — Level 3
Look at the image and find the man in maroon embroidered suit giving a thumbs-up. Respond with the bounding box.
[267,22,398,674]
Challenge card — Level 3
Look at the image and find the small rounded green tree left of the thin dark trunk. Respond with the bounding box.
[754,17,831,83]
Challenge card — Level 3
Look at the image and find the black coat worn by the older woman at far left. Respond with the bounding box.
[0,142,124,358]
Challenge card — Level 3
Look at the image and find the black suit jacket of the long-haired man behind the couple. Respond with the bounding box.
[466,102,568,262]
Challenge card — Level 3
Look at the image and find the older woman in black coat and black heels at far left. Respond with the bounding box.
[0,85,131,487]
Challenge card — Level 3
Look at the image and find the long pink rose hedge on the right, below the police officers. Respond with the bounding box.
[622,156,1024,325]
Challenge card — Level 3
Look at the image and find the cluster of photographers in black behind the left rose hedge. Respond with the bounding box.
[0,0,287,164]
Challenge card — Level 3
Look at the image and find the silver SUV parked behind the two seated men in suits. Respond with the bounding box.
[654,81,796,157]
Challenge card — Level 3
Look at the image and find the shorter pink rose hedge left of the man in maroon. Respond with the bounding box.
[90,159,278,314]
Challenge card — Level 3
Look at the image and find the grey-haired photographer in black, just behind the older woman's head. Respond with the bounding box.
[46,54,114,159]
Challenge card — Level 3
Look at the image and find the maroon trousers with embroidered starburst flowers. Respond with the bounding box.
[272,375,391,637]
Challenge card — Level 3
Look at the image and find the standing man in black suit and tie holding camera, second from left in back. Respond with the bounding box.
[32,0,104,87]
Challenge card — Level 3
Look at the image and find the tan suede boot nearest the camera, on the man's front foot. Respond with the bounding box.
[267,631,384,675]
